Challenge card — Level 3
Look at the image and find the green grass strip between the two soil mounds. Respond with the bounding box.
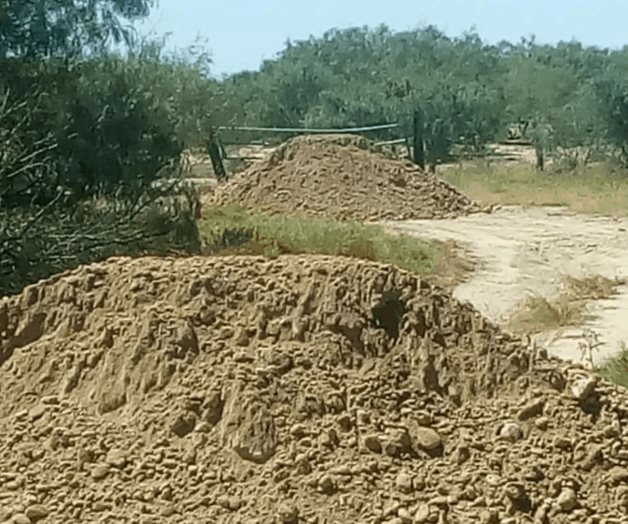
[199,206,472,286]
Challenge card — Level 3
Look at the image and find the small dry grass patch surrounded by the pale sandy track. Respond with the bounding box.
[508,275,623,333]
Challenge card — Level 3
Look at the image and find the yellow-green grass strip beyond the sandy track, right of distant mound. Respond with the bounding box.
[439,162,628,216]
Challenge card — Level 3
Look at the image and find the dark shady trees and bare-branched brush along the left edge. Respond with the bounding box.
[0,0,211,295]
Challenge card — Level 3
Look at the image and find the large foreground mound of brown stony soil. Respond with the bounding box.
[0,257,628,524]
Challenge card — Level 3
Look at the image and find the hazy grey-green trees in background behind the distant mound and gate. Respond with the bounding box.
[215,27,628,168]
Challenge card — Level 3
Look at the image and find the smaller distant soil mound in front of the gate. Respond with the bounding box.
[212,136,479,220]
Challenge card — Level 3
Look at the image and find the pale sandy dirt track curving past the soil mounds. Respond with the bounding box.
[386,207,628,363]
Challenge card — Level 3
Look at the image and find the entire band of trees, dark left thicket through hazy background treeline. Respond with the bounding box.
[0,0,628,295]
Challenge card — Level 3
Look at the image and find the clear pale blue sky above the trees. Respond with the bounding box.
[141,0,628,75]
